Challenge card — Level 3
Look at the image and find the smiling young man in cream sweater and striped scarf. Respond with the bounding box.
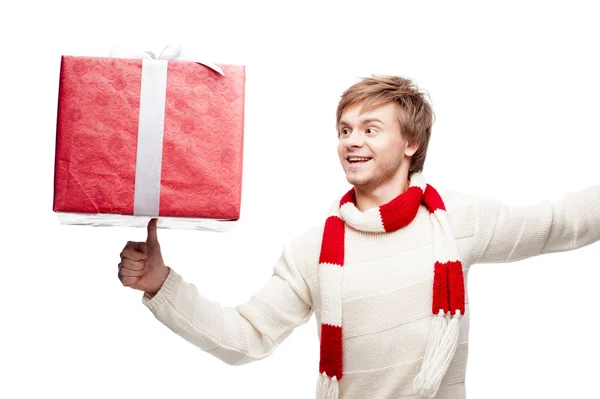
[119,76,600,399]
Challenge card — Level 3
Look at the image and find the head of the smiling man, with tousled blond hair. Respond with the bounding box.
[336,76,434,191]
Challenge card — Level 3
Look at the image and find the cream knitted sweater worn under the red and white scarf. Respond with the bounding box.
[142,185,600,399]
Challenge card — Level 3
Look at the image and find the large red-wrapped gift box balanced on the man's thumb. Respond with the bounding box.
[53,53,245,228]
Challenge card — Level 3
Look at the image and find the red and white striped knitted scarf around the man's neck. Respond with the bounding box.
[317,173,465,399]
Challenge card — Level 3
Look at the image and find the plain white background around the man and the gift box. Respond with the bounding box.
[0,0,600,399]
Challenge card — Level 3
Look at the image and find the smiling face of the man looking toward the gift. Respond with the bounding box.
[338,103,416,191]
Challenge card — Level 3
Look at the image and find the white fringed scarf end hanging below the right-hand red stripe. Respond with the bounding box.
[413,310,461,398]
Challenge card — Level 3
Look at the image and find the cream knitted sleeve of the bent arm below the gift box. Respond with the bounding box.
[142,246,313,365]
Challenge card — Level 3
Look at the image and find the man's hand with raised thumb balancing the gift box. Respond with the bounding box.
[118,218,169,296]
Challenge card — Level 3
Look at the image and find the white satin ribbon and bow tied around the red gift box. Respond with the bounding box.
[110,45,225,217]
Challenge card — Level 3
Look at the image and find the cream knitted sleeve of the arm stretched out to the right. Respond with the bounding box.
[472,185,600,263]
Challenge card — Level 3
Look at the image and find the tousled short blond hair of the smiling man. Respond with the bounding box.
[336,75,435,177]
